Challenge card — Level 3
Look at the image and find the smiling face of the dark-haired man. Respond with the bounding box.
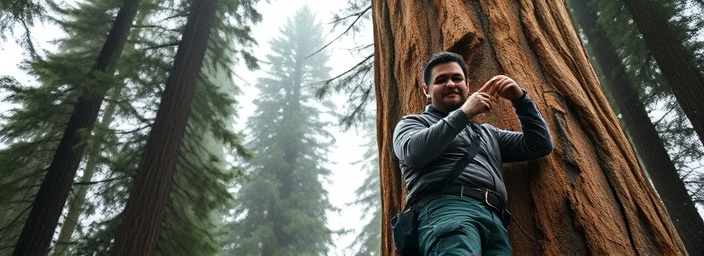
[423,62,469,113]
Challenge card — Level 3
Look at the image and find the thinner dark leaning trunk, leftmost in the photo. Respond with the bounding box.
[13,0,139,255]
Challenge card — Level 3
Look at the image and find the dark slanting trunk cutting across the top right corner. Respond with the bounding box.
[624,0,704,146]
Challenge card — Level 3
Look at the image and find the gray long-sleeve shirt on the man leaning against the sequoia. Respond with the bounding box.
[393,94,553,207]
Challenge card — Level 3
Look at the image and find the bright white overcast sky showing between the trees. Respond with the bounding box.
[0,0,371,255]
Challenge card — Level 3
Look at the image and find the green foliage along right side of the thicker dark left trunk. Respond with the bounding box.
[150,0,261,252]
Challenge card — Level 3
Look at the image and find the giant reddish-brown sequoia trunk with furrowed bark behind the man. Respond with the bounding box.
[372,0,684,255]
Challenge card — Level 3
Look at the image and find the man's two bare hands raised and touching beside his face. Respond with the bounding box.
[460,75,524,119]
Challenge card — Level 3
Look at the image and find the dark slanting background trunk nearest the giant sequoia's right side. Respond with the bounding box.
[570,0,704,255]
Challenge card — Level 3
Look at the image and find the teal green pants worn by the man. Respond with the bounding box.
[418,195,512,256]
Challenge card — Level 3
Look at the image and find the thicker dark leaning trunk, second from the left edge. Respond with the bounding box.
[111,0,218,255]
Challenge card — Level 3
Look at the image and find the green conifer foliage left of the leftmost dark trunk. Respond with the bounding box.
[0,1,118,251]
